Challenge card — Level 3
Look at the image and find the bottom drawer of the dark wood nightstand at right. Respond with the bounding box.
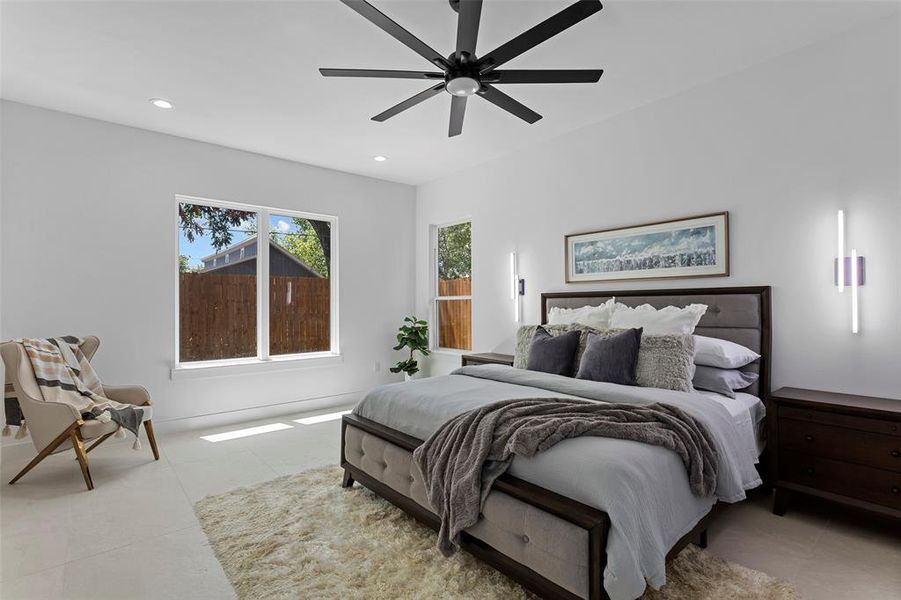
[779,450,901,509]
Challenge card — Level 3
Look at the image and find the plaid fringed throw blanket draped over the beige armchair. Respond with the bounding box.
[19,336,144,450]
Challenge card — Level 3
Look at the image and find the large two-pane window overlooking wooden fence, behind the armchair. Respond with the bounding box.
[176,197,338,364]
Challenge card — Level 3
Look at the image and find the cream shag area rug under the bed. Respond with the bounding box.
[195,467,798,600]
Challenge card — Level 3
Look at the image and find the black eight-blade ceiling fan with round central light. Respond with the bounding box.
[319,0,604,137]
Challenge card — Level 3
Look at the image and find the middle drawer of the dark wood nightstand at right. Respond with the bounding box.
[779,420,901,472]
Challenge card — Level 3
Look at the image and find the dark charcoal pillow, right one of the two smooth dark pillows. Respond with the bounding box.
[576,327,642,385]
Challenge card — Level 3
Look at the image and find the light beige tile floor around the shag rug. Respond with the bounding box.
[0,411,901,600]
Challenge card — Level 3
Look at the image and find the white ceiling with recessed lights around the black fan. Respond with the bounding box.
[0,0,897,184]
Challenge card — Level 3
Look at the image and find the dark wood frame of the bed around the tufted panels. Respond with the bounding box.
[341,286,771,600]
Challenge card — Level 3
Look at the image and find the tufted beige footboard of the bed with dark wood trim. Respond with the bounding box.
[341,415,707,600]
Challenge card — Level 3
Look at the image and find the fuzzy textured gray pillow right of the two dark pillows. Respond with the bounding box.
[635,333,695,392]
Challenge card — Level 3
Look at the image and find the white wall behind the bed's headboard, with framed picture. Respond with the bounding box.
[416,16,901,398]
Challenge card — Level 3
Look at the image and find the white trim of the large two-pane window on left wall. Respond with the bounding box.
[170,194,343,372]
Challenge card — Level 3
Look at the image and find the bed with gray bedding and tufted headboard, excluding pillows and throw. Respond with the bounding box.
[341,287,770,600]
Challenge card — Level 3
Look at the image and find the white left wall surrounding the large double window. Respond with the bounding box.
[0,102,415,421]
